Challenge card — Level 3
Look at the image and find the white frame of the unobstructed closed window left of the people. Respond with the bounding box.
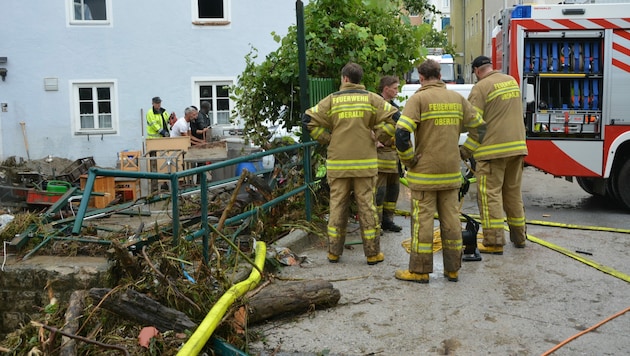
[70,79,120,136]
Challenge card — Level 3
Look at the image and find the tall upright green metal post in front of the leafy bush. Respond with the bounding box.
[295,0,313,221]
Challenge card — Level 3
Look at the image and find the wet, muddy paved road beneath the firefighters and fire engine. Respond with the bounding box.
[250,168,630,355]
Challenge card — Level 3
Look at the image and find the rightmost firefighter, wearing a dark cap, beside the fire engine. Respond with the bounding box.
[461,56,527,254]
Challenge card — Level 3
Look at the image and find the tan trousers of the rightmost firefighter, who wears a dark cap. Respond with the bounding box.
[476,156,526,246]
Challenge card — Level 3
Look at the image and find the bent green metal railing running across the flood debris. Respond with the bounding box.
[72,141,317,262]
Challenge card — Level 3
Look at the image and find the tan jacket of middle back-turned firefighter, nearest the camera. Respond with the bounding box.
[396,82,483,191]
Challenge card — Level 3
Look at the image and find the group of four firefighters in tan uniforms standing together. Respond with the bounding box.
[302,56,527,283]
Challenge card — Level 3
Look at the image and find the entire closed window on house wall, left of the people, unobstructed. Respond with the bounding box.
[72,82,117,135]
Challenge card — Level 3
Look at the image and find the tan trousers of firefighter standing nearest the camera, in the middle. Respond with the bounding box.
[409,189,462,273]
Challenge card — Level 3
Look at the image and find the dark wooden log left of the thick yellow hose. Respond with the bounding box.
[90,288,197,332]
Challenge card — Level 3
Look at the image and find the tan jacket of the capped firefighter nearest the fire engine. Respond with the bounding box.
[464,71,527,160]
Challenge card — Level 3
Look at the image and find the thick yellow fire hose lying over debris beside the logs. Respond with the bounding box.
[177,241,267,356]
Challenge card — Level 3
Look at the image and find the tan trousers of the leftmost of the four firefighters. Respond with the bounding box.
[328,176,381,257]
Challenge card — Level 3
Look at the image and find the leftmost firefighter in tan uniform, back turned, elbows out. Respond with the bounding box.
[302,63,397,265]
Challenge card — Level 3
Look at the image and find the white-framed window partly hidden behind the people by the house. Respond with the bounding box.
[196,80,233,125]
